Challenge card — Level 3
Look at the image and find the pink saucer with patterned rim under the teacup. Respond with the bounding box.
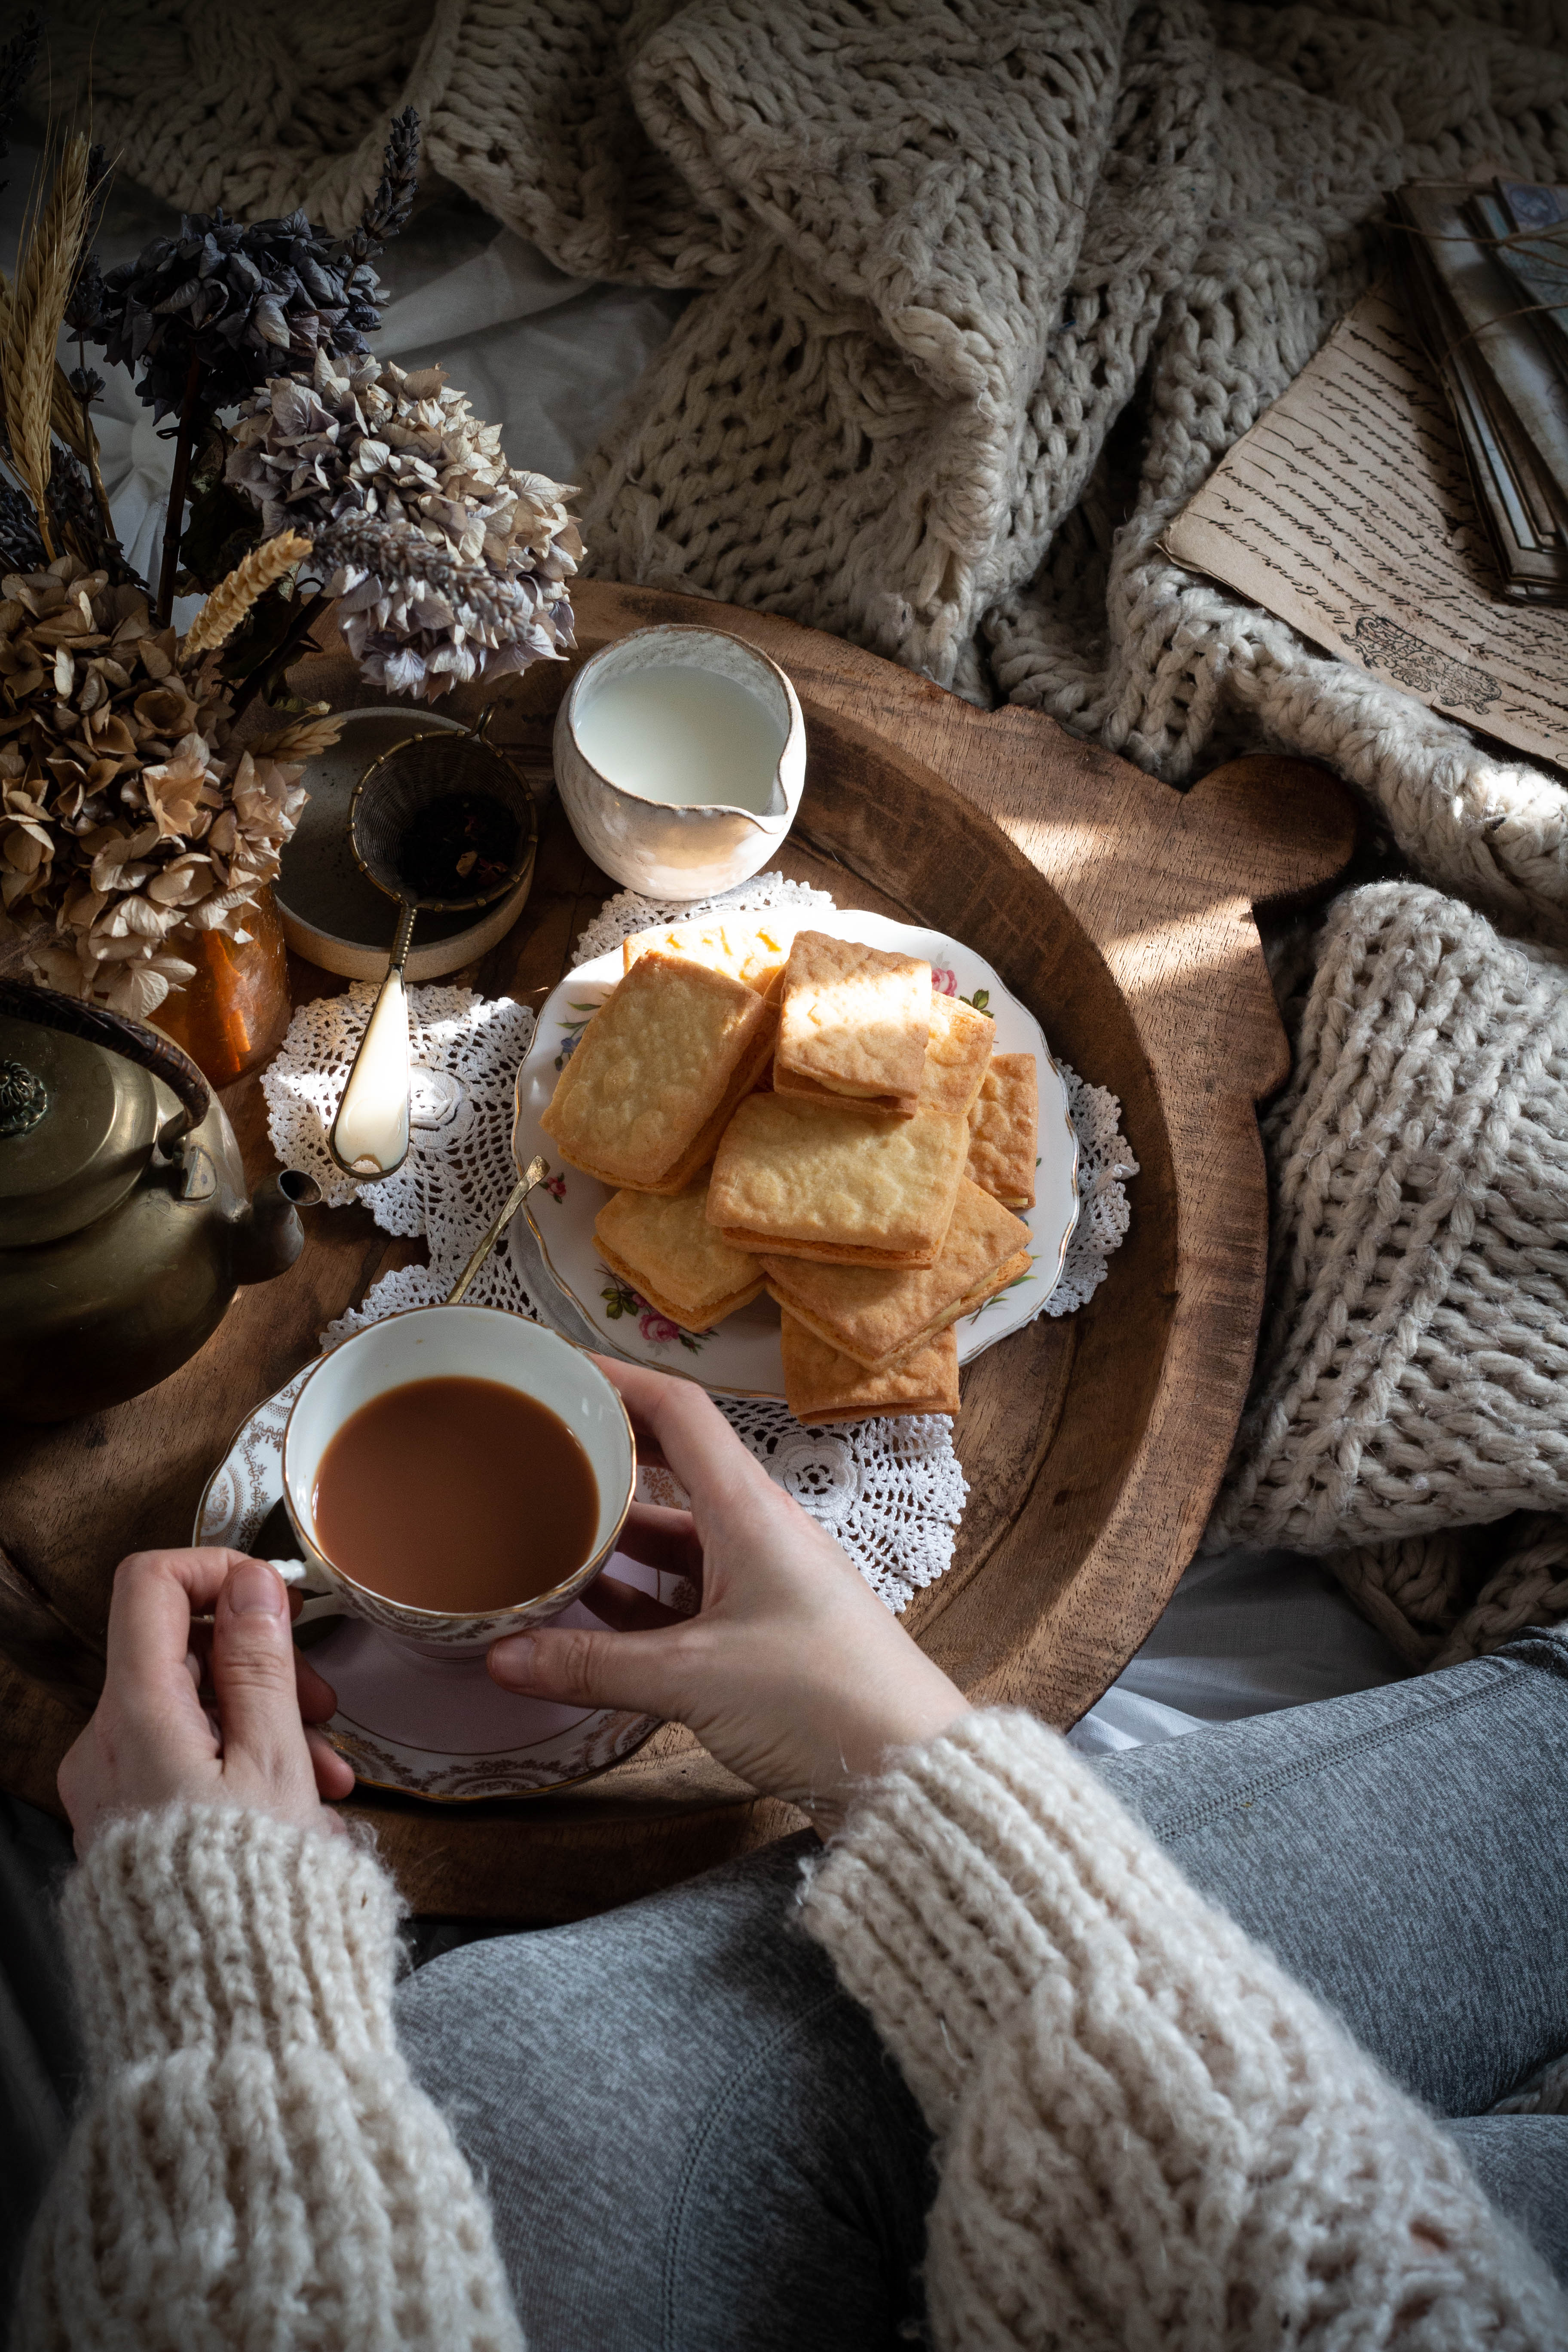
[190,1366,672,1804]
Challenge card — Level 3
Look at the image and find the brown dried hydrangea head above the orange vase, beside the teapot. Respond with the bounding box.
[0,555,322,1018]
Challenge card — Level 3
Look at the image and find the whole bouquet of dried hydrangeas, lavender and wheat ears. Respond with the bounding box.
[0,78,581,1016]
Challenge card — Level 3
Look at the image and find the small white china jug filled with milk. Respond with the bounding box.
[555,621,806,898]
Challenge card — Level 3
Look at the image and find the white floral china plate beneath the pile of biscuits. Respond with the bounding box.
[512,910,1079,1400]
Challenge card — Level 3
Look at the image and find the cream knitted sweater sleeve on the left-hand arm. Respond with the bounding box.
[12,1806,522,2352]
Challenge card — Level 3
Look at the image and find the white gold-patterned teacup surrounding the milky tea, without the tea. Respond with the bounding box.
[282,1305,637,1651]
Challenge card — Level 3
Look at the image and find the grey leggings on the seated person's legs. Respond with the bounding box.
[397,1635,1568,2352]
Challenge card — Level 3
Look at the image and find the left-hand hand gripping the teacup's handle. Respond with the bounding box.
[59,1548,355,1853]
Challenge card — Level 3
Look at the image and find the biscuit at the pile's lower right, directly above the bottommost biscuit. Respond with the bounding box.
[762,1178,1032,1371]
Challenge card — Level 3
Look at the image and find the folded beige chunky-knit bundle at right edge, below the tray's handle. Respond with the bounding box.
[1206,882,1568,1599]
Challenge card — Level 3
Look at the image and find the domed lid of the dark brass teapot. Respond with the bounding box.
[0,1014,157,1249]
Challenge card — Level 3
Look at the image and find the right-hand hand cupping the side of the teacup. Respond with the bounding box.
[489,1357,968,1830]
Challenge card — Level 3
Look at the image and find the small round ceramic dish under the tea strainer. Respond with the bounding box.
[273,703,534,983]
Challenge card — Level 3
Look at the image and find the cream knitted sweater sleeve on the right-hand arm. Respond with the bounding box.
[802,1712,1568,2352]
